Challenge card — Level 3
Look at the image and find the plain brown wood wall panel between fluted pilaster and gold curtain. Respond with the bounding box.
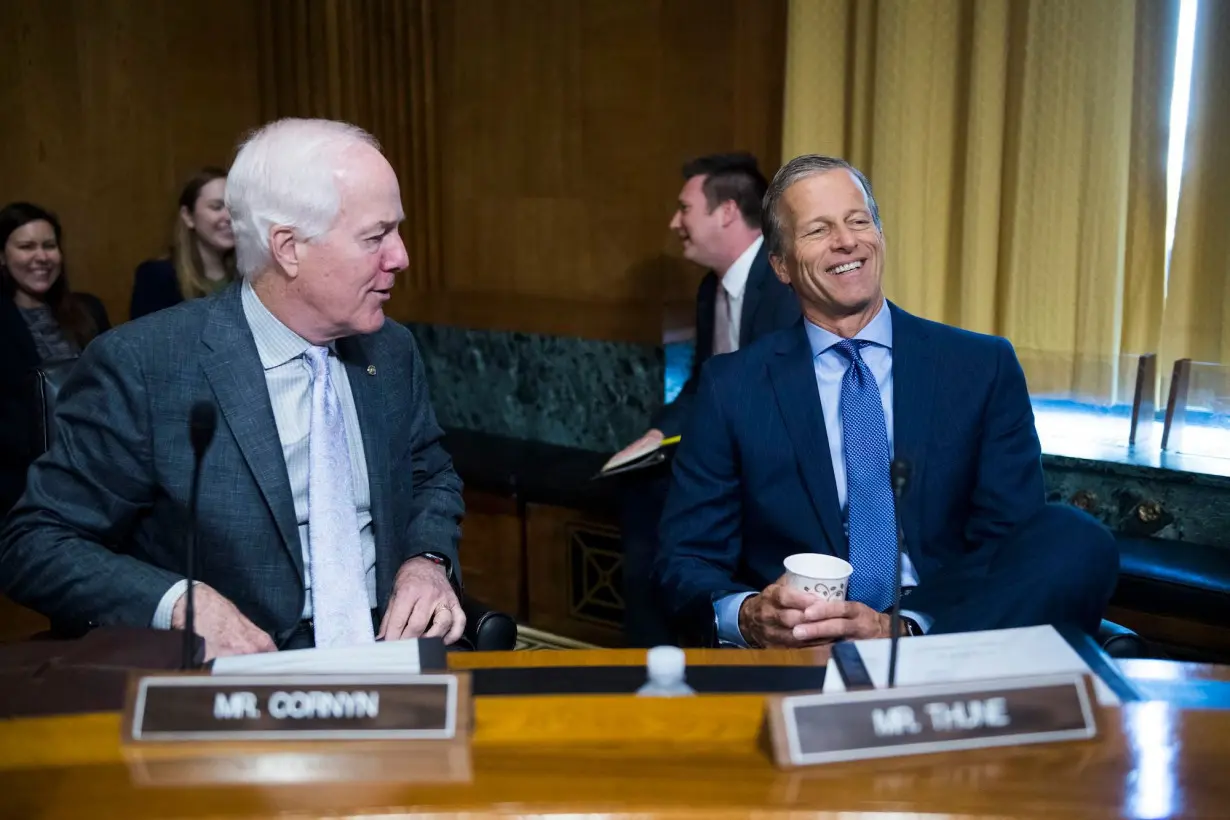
[423,0,785,339]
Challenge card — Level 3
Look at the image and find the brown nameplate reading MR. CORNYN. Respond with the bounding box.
[124,675,470,743]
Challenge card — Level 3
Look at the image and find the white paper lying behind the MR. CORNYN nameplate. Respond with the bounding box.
[213,641,422,675]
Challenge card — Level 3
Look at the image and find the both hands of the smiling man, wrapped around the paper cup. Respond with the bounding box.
[739,579,889,649]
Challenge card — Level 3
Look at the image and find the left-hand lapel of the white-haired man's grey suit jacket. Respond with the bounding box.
[200,285,304,580]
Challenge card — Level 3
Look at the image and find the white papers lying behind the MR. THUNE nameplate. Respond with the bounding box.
[822,626,1119,706]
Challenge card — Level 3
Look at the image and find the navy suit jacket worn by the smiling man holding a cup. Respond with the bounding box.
[654,304,1046,642]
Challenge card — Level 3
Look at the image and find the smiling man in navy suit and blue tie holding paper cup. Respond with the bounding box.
[654,155,1118,647]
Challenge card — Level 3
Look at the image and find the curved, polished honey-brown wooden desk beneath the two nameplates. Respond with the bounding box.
[0,650,1230,819]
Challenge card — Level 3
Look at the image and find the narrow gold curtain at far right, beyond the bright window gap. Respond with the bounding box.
[1162,0,1230,366]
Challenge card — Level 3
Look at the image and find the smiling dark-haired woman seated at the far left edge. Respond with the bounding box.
[0,202,111,516]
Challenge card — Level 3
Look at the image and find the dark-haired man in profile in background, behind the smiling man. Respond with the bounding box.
[616,154,800,645]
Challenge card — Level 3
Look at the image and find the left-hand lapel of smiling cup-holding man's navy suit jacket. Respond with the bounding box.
[769,322,849,558]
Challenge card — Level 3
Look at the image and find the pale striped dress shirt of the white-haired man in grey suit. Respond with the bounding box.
[151,282,376,629]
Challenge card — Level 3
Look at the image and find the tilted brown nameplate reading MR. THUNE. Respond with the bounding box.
[768,675,1097,766]
